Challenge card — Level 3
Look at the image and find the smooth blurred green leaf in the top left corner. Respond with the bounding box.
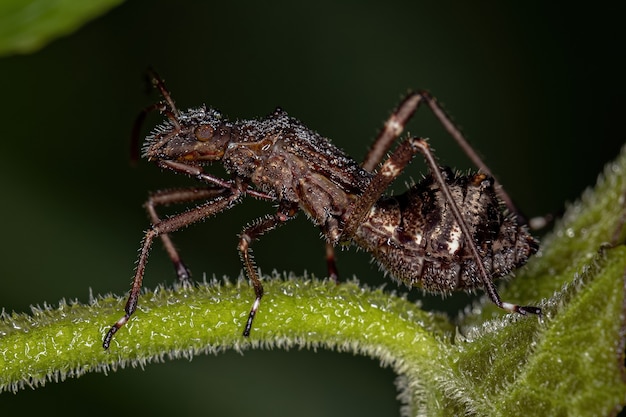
[0,0,122,56]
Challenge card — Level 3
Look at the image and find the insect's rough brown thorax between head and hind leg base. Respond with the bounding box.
[223,110,372,228]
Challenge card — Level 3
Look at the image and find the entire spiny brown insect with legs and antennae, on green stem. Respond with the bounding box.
[103,73,541,349]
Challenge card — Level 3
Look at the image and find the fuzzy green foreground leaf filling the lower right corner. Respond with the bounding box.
[453,246,626,416]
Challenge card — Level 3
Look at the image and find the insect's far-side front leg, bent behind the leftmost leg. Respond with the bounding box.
[144,187,229,287]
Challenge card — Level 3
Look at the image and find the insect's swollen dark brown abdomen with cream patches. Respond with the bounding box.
[354,171,537,293]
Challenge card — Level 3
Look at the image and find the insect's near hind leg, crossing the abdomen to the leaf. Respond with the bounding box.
[344,138,541,315]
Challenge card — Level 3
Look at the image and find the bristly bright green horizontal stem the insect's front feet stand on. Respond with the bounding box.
[0,277,453,406]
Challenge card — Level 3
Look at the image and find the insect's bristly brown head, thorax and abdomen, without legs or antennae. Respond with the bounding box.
[144,107,537,293]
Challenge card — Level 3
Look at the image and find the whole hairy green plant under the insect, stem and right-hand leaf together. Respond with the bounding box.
[0,142,626,416]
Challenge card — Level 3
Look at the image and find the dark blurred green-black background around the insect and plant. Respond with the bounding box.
[0,0,626,416]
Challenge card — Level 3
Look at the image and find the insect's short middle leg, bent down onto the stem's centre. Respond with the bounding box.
[238,204,298,337]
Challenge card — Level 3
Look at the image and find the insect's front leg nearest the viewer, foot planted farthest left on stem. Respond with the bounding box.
[102,190,242,349]
